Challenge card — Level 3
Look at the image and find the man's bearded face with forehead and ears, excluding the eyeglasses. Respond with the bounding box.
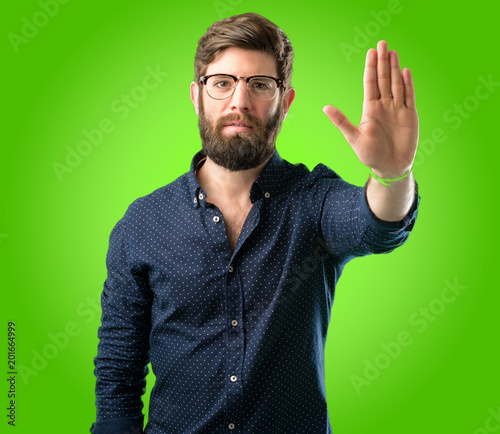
[191,47,295,171]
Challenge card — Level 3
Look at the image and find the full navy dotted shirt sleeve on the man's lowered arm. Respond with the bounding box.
[90,217,152,434]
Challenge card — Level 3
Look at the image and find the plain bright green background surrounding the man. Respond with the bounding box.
[0,0,500,434]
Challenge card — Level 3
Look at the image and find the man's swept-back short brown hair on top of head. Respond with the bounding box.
[194,12,293,89]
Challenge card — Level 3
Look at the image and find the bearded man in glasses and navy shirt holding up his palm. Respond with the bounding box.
[91,13,419,434]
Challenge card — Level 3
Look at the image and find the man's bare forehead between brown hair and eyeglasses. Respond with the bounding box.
[206,47,278,77]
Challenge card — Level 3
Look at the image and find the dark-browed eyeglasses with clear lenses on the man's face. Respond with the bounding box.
[200,74,283,101]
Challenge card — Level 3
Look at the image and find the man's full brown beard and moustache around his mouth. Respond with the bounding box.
[198,92,283,172]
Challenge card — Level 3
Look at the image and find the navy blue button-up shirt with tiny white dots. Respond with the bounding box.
[91,151,420,434]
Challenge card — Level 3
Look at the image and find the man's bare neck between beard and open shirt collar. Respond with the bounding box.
[196,157,272,201]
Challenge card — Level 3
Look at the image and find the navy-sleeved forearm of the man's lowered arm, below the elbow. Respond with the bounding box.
[92,289,149,434]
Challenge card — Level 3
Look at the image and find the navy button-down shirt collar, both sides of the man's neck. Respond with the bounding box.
[188,149,285,208]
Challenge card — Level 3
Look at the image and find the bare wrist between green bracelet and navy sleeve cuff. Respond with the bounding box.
[366,172,415,222]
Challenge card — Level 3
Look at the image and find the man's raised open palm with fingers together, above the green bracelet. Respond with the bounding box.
[323,41,418,178]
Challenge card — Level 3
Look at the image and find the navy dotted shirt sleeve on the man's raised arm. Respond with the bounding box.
[317,177,420,263]
